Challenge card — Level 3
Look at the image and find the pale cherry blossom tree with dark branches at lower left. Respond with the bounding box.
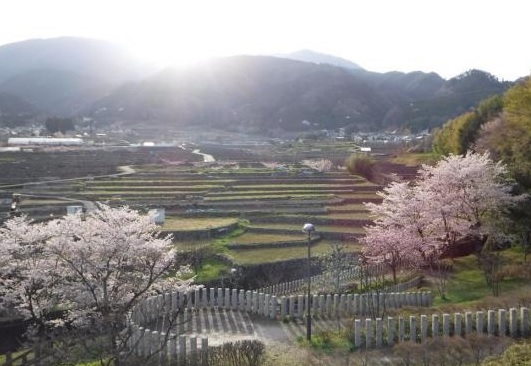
[0,205,190,364]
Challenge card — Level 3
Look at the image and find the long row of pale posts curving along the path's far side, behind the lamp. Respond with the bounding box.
[131,288,432,325]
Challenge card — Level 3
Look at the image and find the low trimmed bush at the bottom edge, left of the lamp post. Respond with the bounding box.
[208,340,265,366]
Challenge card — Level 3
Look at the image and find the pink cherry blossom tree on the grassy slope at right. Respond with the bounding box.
[363,152,522,294]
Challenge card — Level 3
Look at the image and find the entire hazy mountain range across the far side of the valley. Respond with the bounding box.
[0,38,508,134]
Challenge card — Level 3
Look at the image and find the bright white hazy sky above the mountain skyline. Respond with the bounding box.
[0,0,531,80]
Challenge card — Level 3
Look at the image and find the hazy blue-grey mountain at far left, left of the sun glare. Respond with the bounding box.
[0,37,155,115]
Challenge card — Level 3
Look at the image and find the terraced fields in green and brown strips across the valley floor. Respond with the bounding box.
[2,144,381,264]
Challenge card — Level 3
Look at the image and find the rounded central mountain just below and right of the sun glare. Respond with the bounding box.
[93,56,391,132]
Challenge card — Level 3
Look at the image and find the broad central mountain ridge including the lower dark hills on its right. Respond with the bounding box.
[92,56,507,133]
